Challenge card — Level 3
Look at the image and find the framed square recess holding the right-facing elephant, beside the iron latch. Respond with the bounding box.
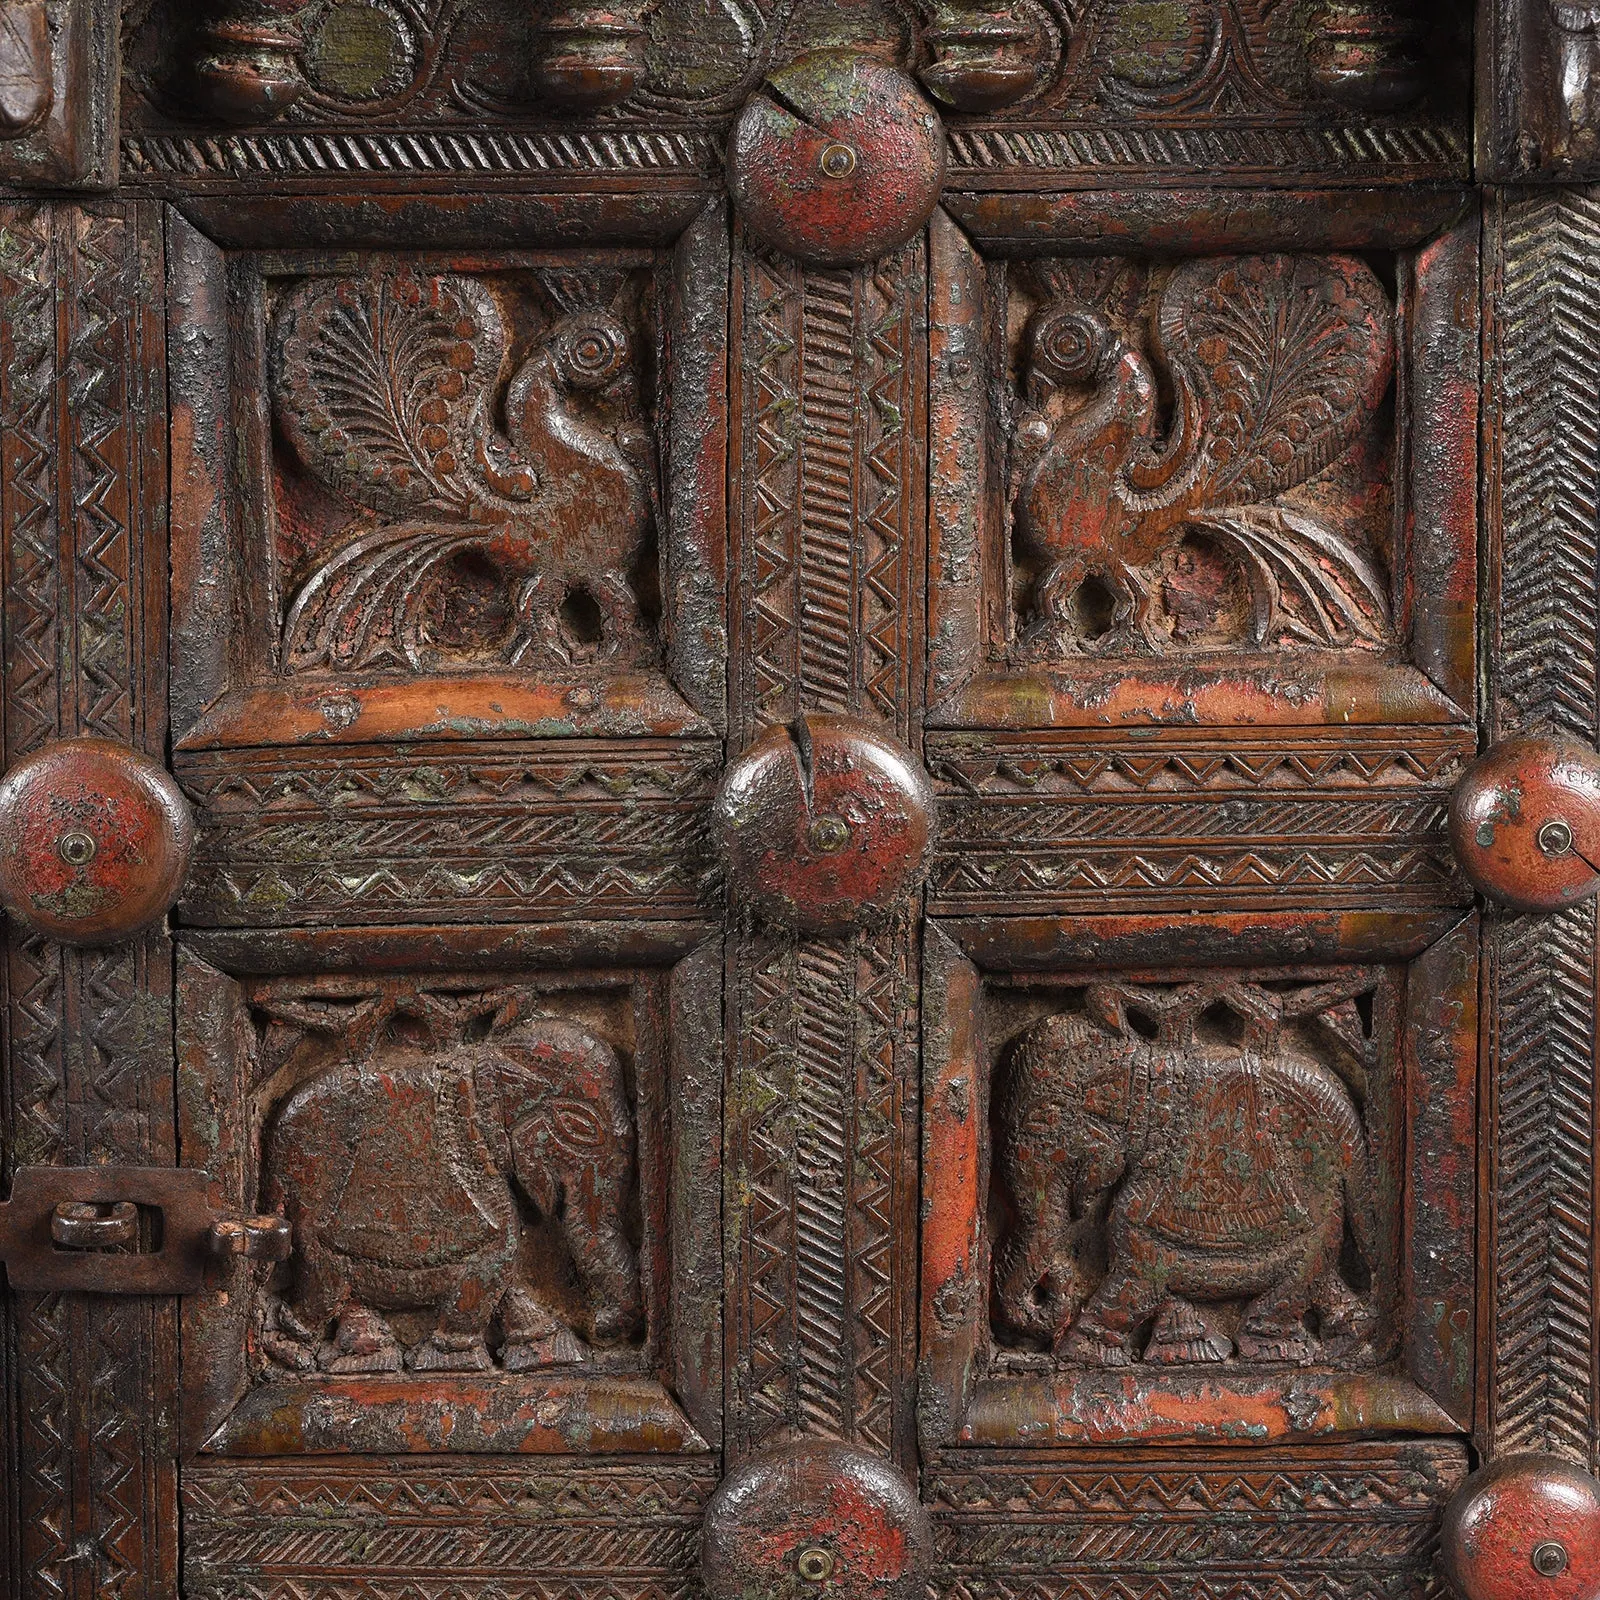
[181,952,717,1454]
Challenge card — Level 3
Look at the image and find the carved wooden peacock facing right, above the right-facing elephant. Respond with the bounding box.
[272,267,656,672]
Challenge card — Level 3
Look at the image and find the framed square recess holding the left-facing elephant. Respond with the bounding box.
[923,926,1475,1446]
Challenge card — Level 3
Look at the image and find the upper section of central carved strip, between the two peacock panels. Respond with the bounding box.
[733,240,928,744]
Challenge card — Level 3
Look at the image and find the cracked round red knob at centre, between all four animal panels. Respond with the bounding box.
[712,717,933,933]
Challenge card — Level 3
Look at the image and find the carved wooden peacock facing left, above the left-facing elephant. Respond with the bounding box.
[1011,254,1394,656]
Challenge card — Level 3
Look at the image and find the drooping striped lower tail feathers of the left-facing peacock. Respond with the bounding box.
[1195,506,1390,650]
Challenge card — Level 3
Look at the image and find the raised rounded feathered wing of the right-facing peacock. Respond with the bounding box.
[275,270,518,522]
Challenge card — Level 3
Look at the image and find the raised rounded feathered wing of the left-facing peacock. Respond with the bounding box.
[1157,254,1394,504]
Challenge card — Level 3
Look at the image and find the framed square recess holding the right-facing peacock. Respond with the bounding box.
[173,222,723,749]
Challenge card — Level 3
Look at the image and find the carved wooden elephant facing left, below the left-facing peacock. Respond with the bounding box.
[995,987,1379,1366]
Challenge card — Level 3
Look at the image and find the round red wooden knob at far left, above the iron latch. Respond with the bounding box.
[0,739,194,944]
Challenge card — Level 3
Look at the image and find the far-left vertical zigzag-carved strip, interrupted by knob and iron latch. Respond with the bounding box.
[0,205,176,1597]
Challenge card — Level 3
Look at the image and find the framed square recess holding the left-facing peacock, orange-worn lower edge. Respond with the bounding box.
[930,212,1477,728]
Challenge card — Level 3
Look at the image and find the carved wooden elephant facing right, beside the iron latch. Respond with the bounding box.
[261,995,642,1373]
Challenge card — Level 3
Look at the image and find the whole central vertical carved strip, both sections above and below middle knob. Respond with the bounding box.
[726,242,926,1456]
